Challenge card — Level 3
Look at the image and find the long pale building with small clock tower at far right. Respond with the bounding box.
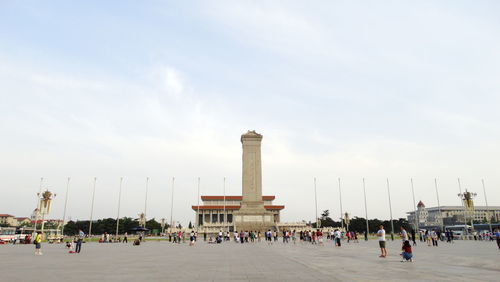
[407,201,500,228]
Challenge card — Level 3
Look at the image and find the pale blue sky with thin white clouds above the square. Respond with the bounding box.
[0,0,500,224]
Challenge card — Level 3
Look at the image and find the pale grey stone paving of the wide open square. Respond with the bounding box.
[0,240,500,281]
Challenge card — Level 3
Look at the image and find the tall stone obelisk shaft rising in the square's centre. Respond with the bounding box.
[241,130,264,209]
